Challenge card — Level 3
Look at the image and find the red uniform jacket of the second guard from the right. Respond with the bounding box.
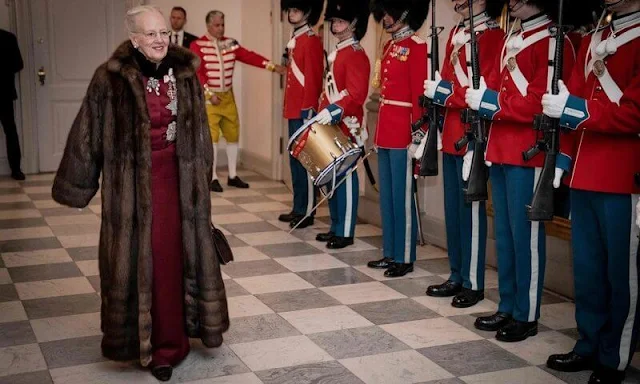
[481,15,575,167]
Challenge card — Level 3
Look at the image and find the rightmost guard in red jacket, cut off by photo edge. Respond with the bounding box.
[542,0,640,383]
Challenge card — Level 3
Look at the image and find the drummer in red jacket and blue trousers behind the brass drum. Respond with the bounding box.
[315,0,371,249]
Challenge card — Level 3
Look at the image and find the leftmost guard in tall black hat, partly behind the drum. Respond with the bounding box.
[278,0,324,228]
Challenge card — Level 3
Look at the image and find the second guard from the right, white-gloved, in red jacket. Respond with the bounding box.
[465,0,575,342]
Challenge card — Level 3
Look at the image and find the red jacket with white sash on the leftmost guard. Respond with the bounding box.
[284,25,324,119]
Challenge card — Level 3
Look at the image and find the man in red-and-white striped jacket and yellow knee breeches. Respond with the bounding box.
[190,11,285,192]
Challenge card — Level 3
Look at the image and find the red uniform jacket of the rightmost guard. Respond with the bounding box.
[561,20,640,194]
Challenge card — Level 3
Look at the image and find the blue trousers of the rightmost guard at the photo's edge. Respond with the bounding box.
[571,189,639,371]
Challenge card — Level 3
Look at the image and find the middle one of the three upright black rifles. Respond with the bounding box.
[455,0,489,203]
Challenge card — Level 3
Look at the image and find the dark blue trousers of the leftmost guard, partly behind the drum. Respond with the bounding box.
[289,119,316,216]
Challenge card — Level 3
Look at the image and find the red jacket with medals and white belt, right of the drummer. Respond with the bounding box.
[375,34,427,149]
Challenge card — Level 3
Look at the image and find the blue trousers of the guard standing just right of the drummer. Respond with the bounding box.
[378,148,418,264]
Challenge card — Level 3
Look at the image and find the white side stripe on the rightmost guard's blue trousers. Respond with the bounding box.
[618,195,640,371]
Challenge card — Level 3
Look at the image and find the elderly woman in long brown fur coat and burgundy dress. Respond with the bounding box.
[53,6,229,381]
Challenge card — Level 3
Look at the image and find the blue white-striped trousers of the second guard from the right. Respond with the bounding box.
[490,164,546,322]
